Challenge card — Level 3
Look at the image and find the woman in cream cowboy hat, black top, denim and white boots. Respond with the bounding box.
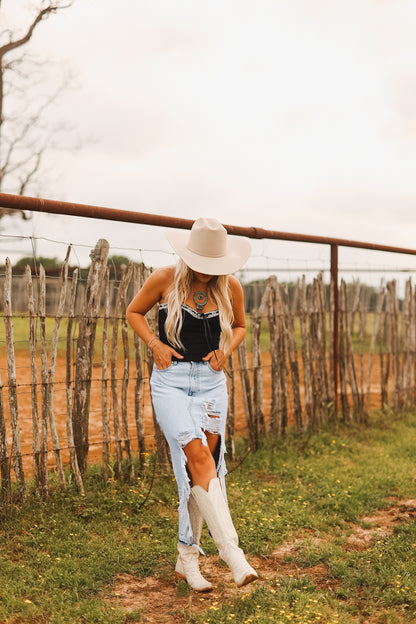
[127,218,257,591]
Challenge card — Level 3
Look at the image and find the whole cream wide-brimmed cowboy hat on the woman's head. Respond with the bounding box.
[166,217,251,275]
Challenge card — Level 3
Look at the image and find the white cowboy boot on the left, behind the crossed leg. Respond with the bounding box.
[175,497,212,592]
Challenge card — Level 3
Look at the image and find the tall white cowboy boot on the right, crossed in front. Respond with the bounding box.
[191,478,258,587]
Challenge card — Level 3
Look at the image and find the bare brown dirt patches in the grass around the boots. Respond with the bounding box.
[105,500,416,624]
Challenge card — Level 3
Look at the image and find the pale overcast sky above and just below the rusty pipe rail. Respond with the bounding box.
[1,0,416,282]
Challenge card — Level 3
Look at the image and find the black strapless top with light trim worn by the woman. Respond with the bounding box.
[159,303,221,362]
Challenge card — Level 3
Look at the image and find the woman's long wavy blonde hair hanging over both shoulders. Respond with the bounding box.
[165,259,234,352]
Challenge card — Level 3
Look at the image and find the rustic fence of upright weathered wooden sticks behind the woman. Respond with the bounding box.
[0,240,416,501]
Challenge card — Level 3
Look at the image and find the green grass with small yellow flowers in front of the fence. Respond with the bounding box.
[0,414,416,624]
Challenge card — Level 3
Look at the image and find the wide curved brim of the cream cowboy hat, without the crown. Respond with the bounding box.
[166,230,251,275]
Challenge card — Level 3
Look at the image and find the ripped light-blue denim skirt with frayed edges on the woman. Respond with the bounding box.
[150,361,228,546]
